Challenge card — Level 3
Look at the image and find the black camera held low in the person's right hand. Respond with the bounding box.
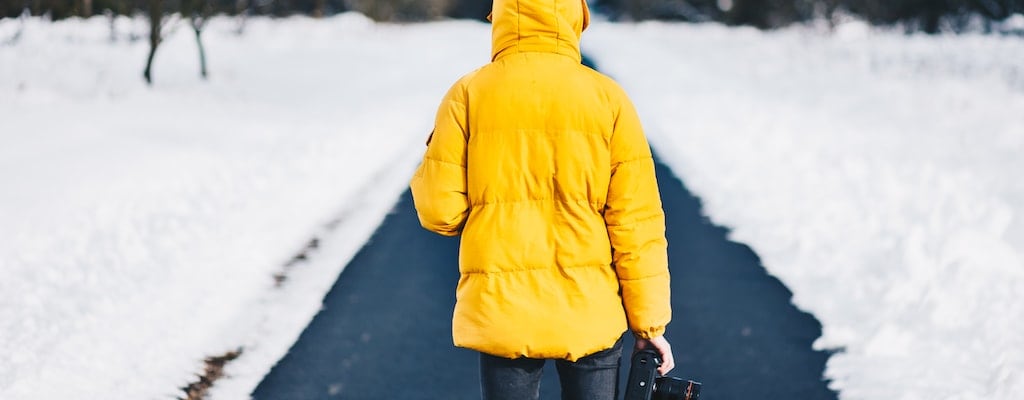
[625,350,700,400]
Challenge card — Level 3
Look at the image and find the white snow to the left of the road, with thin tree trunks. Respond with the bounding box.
[0,14,489,399]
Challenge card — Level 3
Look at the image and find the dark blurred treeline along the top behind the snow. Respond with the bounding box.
[0,0,1024,33]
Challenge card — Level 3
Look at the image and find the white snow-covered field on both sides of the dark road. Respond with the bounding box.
[0,10,1024,400]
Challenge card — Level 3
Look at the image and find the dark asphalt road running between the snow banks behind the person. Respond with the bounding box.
[253,157,837,400]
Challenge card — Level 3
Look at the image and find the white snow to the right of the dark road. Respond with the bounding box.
[584,23,1024,400]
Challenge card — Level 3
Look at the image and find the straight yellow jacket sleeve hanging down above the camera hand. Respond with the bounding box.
[604,94,672,339]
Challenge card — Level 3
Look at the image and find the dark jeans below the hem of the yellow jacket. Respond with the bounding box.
[480,339,623,400]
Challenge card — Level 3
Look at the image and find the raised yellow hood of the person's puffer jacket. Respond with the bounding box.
[487,0,590,60]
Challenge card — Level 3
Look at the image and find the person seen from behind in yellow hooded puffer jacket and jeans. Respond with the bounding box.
[410,0,674,400]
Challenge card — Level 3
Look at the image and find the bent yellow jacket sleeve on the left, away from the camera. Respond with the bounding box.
[410,79,469,236]
